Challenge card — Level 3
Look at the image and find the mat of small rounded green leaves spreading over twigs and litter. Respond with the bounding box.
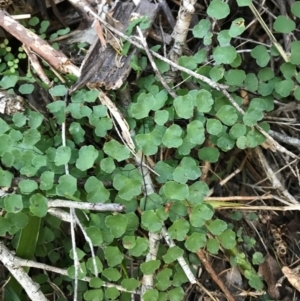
[0,0,292,301]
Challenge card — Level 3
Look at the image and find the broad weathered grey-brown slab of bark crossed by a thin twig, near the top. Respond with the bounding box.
[71,0,159,93]
